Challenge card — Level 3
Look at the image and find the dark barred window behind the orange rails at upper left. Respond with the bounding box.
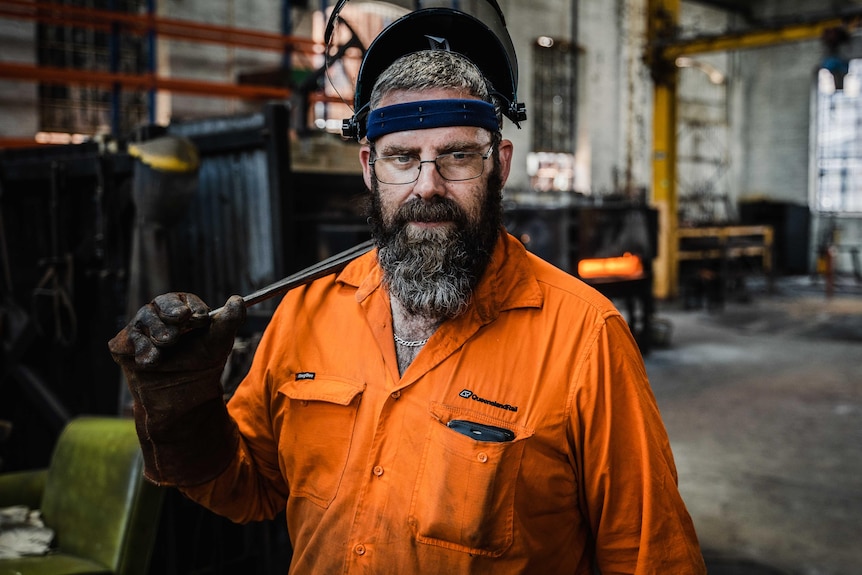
[37,0,147,135]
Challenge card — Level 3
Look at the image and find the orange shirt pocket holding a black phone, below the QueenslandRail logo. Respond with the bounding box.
[410,404,532,557]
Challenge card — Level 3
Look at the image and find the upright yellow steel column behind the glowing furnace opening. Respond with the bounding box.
[647,0,680,298]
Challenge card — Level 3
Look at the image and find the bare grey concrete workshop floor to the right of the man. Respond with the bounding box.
[646,278,862,575]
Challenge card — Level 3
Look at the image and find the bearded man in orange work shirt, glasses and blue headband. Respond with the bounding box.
[110,27,705,575]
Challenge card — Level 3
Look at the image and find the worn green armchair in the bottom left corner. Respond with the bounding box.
[0,417,164,575]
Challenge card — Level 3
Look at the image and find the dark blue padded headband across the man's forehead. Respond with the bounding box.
[367,100,500,141]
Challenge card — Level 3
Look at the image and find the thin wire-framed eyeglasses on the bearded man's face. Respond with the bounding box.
[368,145,494,185]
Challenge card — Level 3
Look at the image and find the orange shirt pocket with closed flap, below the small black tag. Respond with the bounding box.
[278,376,365,508]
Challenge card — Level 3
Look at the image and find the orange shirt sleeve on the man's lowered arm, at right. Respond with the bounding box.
[571,315,706,575]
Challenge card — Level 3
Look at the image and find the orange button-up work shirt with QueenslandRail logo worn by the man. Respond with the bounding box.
[185,234,706,575]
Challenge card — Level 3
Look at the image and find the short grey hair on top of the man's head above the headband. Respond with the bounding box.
[369,50,499,110]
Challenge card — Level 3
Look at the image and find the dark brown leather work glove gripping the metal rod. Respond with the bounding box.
[108,293,246,487]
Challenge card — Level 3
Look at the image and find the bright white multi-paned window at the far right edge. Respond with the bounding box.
[813,59,862,214]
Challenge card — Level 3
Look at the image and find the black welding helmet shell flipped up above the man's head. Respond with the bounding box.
[325,0,527,140]
